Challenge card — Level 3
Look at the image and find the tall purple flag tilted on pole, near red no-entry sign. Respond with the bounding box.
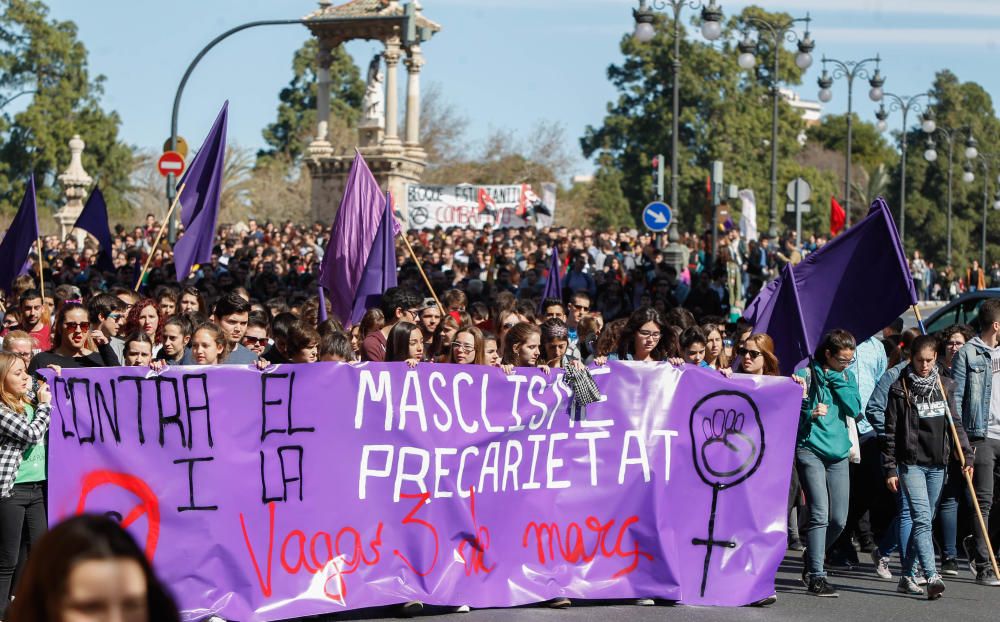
[174,101,229,282]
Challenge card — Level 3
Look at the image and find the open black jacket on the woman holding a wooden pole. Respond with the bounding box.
[881,376,973,477]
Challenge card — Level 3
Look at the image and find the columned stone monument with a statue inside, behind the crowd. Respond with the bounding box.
[305,0,441,223]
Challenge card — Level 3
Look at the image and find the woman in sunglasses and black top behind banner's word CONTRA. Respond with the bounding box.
[28,302,119,373]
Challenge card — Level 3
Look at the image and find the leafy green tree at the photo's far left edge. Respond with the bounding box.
[0,0,133,215]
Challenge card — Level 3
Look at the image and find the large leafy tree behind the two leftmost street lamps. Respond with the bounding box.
[581,7,804,230]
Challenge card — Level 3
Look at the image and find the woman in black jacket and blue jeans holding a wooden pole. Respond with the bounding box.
[882,335,973,600]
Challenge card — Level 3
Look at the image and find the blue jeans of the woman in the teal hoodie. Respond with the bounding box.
[795,447,851,578]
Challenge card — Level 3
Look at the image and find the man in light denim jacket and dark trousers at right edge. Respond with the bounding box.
[951,298,1000,586]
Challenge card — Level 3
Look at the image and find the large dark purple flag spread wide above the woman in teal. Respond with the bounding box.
[743,197,917,373]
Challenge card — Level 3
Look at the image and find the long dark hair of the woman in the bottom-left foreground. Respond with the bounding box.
[6,514,180,622]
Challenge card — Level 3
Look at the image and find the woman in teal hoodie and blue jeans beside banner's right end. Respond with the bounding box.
[795,329,863,598]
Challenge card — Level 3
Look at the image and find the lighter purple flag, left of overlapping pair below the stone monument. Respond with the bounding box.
[319,152,386,326]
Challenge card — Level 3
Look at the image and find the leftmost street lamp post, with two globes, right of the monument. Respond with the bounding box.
[632,0,722,242]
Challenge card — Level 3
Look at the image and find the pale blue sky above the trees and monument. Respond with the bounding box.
[35,0,1000,182]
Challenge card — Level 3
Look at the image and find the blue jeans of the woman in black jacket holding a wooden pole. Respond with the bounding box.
[897,464,944,579]
